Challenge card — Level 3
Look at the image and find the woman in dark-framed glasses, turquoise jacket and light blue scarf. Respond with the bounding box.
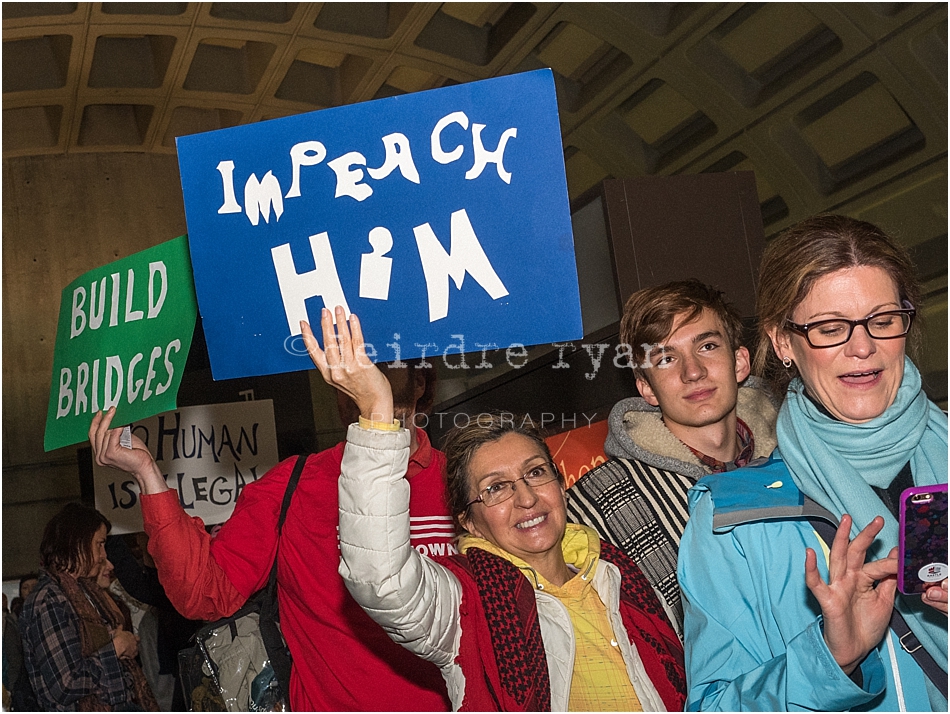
[678,216,947,711]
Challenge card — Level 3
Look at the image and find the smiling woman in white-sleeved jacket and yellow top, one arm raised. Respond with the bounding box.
[302,308,686,711]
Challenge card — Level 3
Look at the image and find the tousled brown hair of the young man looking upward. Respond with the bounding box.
[620,280,742,382]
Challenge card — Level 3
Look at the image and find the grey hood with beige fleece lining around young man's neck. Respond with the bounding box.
[604,376,778,479]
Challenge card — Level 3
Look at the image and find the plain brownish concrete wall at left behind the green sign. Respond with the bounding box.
[2,153,185,580]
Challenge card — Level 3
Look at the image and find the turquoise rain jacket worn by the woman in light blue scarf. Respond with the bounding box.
[677,458,931,711]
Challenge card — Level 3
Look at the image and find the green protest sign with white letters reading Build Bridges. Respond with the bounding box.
[43,236,198,451]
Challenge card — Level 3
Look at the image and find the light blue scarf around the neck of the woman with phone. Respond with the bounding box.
[776,357,947,670]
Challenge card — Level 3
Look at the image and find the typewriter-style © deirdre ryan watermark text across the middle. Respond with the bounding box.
[284,332,663,380]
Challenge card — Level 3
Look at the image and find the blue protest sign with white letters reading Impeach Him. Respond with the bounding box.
[178,70,583,379]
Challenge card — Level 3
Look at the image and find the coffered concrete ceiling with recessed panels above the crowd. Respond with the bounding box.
[3,2,947,237]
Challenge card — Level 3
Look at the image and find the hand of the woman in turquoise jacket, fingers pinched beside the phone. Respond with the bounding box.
[805,514,900,675]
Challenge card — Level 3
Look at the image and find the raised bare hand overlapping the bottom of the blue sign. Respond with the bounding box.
[300,306,393,423]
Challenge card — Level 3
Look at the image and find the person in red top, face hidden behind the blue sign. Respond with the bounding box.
[89,362,454,711]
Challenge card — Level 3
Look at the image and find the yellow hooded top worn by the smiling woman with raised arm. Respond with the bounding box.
[459,526,643,711]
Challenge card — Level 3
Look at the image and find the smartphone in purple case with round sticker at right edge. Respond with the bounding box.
[897,483,948,595]
